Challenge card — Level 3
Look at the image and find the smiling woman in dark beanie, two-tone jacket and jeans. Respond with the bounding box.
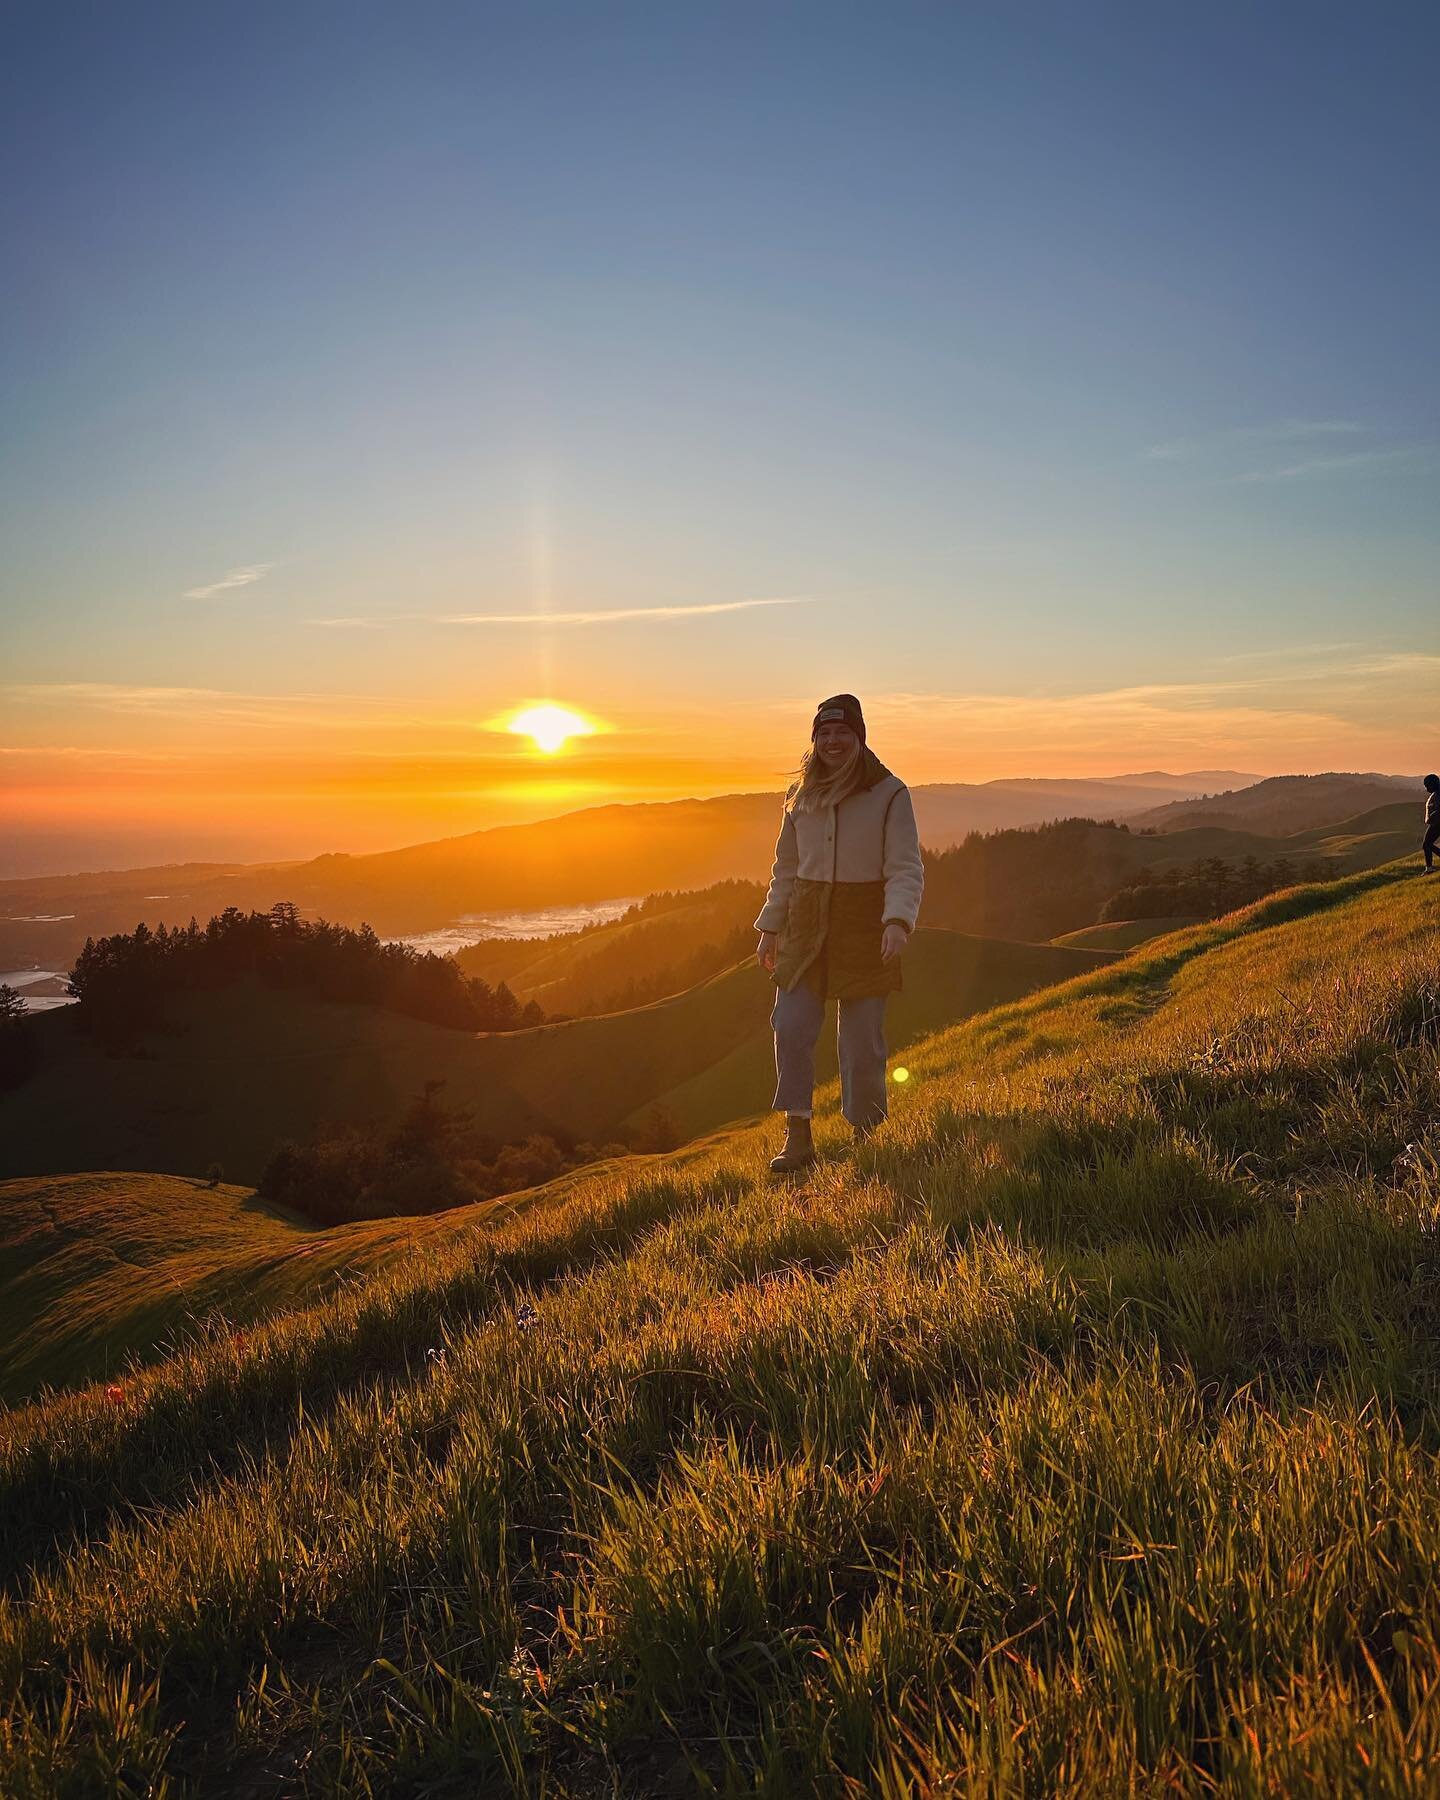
[754,693,925,1174]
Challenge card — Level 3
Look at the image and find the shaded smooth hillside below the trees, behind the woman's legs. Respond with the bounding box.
[0,931,1093,1183]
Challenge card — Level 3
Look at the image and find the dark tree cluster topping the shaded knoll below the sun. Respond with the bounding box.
[68,900,545,1040]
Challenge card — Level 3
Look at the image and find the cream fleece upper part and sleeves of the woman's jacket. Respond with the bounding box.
[754,776,925,931]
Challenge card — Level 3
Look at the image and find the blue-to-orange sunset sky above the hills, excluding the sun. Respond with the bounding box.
[0,4,1440,871]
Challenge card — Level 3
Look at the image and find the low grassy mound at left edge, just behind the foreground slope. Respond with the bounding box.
[0,1174,514,1404]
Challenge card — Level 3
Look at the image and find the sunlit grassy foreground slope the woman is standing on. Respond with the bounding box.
[0,869,1440,1800]
